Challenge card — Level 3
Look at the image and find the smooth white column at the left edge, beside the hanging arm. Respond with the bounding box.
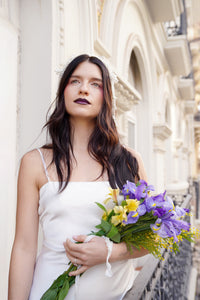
[0,18,18,300]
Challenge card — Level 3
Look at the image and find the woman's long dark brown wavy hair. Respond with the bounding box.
[43,54,139,192]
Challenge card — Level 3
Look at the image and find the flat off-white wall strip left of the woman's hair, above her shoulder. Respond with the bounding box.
[18,0,53,159]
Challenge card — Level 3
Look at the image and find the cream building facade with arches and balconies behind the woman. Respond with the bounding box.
[0,0,200,299]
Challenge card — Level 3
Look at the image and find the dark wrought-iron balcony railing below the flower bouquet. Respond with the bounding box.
[124,194,192,300]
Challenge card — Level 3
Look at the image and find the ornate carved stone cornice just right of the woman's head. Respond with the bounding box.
[115,76,141,111]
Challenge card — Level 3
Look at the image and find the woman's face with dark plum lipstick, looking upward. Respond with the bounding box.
[64,61,103,120]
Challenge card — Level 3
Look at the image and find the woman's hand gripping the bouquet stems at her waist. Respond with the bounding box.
[64,235,108,276]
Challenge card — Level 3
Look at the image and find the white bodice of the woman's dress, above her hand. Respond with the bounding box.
[38,181,109,251]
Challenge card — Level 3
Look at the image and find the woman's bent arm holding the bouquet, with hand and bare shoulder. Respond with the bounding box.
[64,149,149,276]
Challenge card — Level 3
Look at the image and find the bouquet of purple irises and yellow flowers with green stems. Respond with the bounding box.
[41,180,196,300]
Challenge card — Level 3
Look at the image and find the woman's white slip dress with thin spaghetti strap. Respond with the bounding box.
[29,152,136,300]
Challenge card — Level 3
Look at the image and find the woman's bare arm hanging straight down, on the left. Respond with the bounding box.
[8,150,40,300]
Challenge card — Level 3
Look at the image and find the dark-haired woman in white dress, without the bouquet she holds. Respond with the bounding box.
[8,55,147,300]
